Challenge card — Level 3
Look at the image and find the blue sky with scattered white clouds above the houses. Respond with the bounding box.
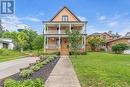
[2,0,130,35]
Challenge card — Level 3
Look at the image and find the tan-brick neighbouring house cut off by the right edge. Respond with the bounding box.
[107,32,130,54]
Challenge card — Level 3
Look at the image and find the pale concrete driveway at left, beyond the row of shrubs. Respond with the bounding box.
[0,57,38,79]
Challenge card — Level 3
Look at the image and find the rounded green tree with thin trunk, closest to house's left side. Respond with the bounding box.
[33,35,44,55]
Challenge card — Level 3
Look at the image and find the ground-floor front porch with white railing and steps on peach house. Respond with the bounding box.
[44,37,86,55]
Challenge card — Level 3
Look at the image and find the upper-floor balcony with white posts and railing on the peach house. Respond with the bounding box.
[44,22,86,35]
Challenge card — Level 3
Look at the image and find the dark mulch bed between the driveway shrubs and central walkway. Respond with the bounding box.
[0,58,59,87]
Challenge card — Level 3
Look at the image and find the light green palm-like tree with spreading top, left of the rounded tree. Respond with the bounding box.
[22,29,38,50]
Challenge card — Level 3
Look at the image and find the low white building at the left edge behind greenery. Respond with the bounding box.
[0,38,14,50]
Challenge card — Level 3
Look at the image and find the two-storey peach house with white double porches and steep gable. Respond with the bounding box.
[43,7,87,54]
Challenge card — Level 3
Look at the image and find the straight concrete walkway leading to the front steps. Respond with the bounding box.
[45,56,80,87]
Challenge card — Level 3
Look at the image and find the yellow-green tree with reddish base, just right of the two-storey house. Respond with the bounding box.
[87,36,106,51]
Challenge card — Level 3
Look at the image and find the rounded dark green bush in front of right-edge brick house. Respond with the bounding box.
[112,43,130,54]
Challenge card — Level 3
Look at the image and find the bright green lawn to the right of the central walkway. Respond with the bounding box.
[71,52,130,87]
